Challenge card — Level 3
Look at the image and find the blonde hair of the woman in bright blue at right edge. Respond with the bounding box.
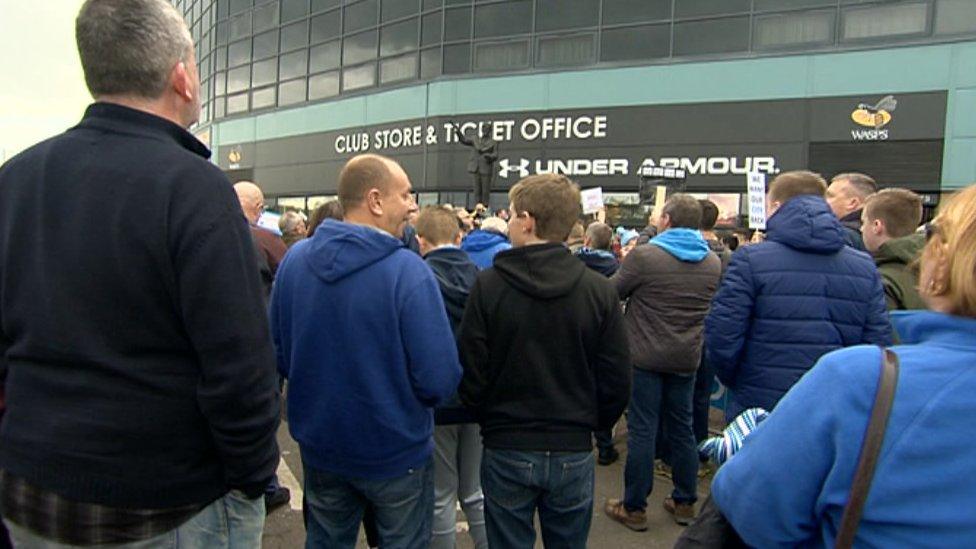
[921,185,976,318]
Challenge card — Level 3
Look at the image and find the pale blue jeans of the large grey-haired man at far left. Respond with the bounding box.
[4,490,264,549]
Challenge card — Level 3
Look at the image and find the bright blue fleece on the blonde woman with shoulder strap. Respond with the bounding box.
[712,311,976,547]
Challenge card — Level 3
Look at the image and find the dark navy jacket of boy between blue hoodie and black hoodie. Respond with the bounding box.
[424,247,478,425]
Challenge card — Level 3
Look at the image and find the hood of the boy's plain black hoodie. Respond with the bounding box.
[495,243,586,299]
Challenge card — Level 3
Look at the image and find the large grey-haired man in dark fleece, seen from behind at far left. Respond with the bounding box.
[0,0,279,548]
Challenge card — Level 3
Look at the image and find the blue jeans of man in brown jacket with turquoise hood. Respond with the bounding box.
[624,368,698,511]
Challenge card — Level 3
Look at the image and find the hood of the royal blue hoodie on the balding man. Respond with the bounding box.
[305,219,404,283]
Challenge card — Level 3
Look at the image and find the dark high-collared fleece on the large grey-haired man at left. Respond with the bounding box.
[0,103,279,508]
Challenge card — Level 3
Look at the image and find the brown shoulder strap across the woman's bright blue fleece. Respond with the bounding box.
[835,349,898,549]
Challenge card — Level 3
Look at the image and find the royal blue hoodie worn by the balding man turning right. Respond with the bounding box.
[271,220,461,479]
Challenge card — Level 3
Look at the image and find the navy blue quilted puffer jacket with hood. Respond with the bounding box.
[705,196,891,418]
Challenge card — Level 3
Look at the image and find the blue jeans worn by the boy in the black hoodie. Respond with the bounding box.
[481,448,593,549]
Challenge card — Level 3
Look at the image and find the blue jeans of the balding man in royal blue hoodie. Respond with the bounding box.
[303,459,434,549]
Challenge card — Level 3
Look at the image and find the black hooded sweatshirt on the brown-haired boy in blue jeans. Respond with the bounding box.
[459,244,630,452]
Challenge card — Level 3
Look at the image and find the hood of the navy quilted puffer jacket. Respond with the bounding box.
[766,195,845,254]
